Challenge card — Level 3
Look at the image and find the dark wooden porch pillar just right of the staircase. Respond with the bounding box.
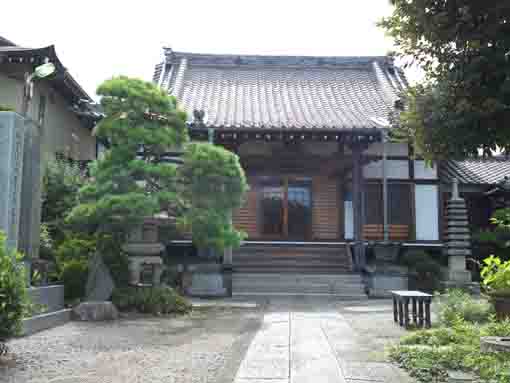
[352,144,365,271]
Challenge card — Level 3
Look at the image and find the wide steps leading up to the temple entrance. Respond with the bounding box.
[232,245,367,299]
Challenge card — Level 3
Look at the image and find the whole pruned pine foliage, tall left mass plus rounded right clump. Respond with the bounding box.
[68,76,246,254]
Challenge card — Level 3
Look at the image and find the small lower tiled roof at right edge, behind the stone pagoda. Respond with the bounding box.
[441,157,510,185]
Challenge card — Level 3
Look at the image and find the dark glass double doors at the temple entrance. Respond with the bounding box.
[261,176,312,241]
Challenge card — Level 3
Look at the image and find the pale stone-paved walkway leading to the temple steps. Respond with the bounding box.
[235,298,411,383]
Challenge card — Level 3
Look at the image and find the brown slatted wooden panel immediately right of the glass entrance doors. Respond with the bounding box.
[312,176,340,240]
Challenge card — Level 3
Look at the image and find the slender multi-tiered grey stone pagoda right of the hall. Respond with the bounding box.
[445,182,471,286]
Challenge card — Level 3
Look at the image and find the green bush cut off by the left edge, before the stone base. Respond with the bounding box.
[0,232,29,354]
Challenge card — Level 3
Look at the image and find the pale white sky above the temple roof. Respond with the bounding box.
[0,0,393,96]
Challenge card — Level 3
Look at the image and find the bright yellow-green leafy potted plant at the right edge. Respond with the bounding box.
[481,255,510,319]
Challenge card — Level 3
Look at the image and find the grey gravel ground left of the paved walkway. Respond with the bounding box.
[0,309,263,383]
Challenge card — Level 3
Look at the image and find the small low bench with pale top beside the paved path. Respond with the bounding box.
[391,290,433,328]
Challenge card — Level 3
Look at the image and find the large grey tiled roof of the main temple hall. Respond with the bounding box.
[154,48,406,129]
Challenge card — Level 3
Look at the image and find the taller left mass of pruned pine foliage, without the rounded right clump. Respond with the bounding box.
[69,77,187,232]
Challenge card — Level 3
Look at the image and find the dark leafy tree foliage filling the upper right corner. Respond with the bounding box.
[380,0,510,159]
